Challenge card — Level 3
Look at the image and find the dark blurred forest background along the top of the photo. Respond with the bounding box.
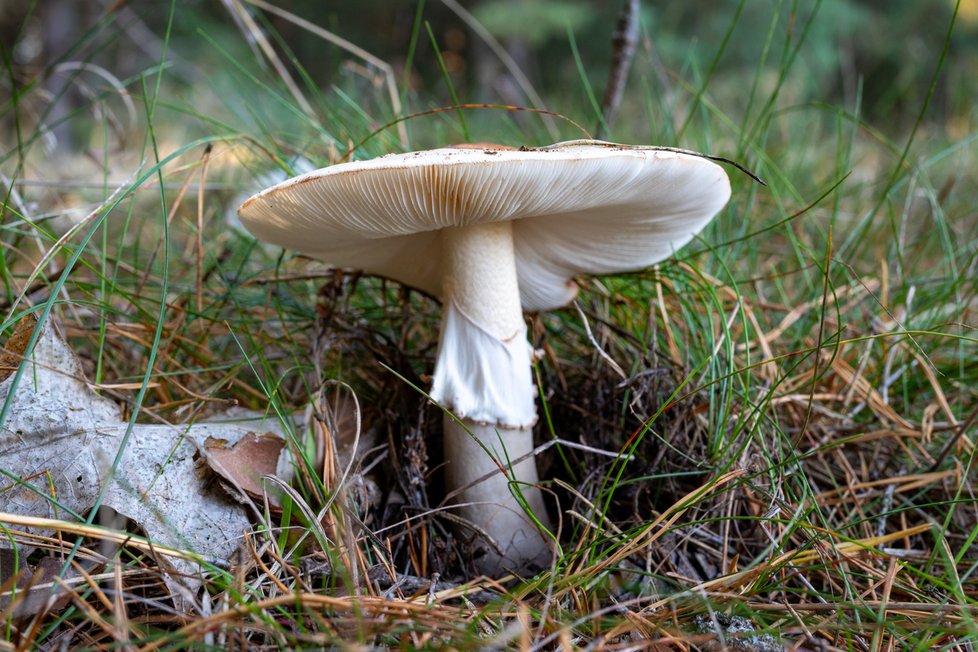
[0,0,978,155]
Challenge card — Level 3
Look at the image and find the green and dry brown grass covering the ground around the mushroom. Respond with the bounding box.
[0,2,978,650]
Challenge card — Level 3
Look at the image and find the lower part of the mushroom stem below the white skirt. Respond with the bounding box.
[444,415,551,576]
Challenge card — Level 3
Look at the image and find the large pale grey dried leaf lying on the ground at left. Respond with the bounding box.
[0,317,286,615]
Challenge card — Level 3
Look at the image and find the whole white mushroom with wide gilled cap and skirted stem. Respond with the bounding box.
[239,141,730,574]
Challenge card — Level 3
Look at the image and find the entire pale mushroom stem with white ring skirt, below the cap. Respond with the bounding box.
[431,222,550,574]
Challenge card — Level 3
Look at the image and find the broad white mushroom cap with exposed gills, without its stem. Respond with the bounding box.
[239,141,730,311]
